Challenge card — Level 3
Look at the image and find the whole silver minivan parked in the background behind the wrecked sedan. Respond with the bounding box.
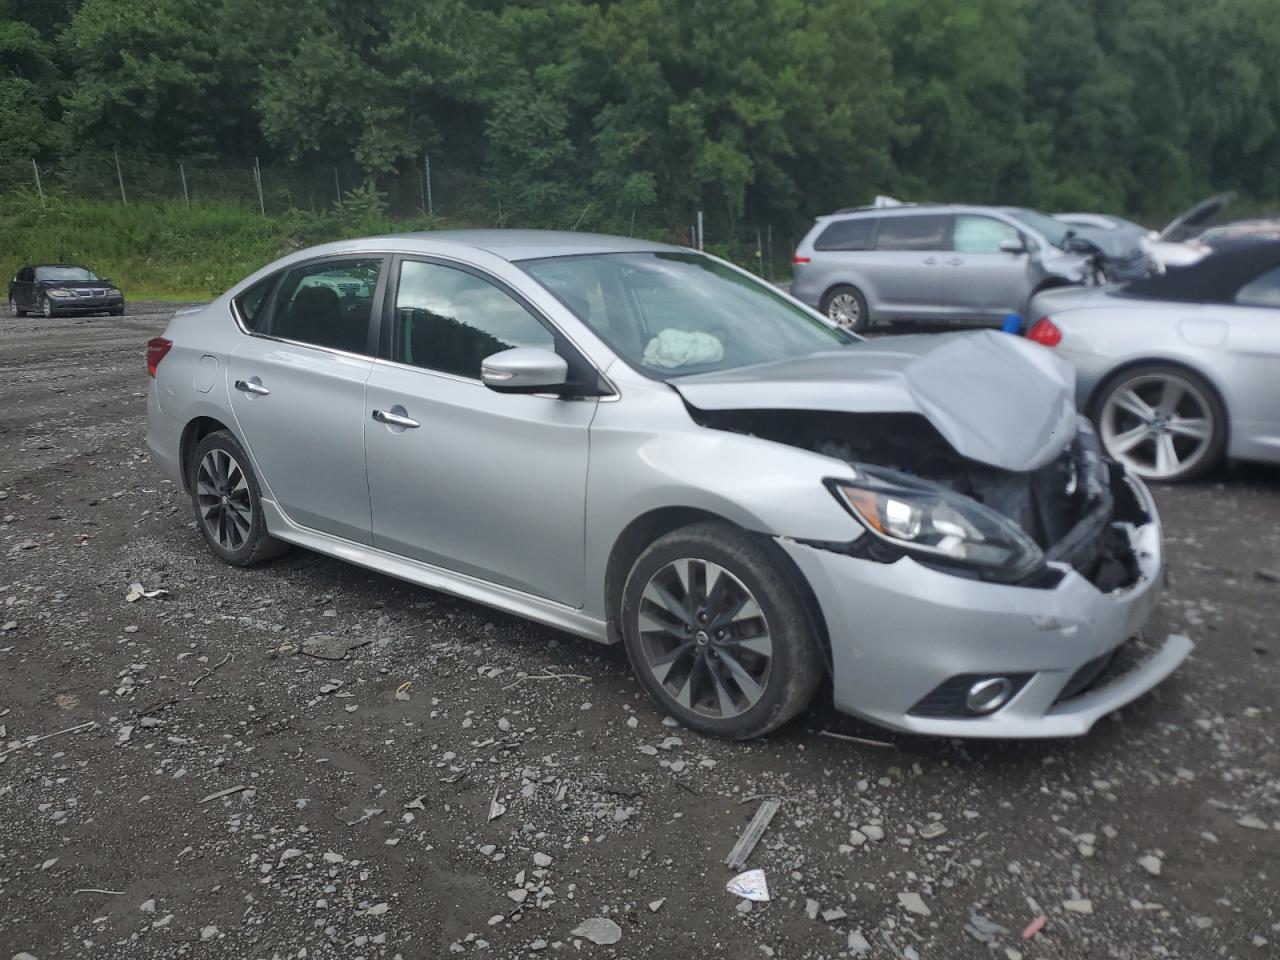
[791,205,1088,330]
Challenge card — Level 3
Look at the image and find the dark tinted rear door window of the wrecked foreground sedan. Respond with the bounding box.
[269,259,383,353]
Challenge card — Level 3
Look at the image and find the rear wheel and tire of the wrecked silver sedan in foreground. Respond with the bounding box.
[188,430,288,567]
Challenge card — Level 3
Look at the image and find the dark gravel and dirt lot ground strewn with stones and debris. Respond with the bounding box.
[0,308,1280,960]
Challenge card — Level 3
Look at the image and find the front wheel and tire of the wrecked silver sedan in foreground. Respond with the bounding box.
[621,522,823,740]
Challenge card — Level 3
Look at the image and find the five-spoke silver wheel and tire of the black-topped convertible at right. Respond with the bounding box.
[1091,364,1228,484]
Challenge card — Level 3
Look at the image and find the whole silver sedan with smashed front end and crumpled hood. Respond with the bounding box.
[147,230,1190,737]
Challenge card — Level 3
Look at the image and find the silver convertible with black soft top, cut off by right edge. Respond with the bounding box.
[1028,242,1280,481]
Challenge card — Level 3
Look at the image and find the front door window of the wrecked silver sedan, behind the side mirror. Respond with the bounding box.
[393,260,556,380]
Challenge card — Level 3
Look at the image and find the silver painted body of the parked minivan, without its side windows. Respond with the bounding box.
[791,205,1084,323]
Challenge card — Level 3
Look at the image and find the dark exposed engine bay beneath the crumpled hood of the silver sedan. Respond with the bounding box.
[689,406,1149,593]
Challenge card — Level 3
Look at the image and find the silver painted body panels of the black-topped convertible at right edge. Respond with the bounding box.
[1029,288,1280,462]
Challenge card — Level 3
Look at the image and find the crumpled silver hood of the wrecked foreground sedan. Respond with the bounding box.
[669,330,1076,471]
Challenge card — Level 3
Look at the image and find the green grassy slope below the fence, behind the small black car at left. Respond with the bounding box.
[0,197,439,300]
